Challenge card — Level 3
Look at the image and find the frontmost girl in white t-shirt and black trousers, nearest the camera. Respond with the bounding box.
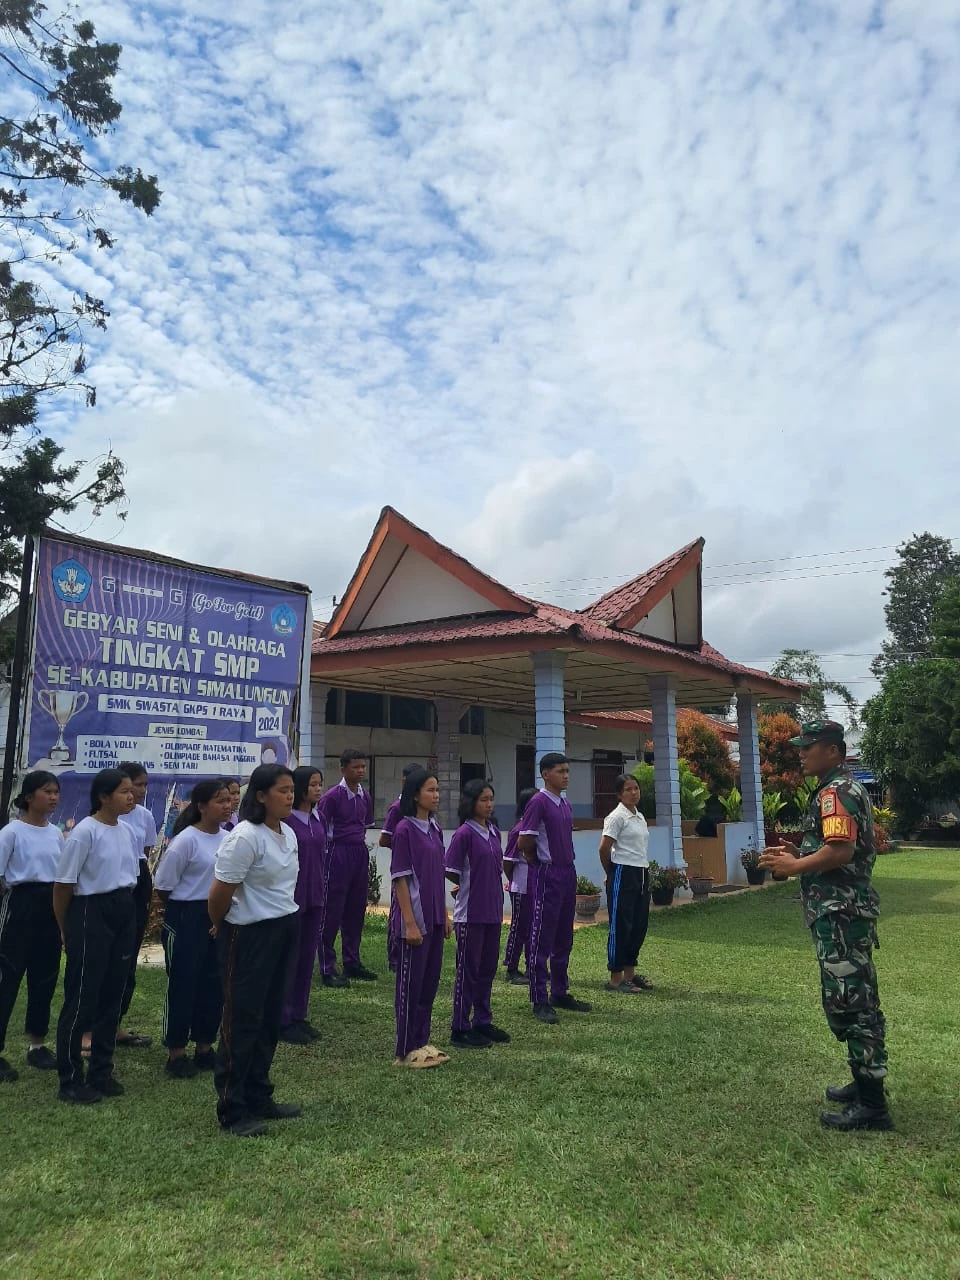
[207,764,301,1138]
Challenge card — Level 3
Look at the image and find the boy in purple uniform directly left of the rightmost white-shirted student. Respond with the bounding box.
[517,751,590,1023]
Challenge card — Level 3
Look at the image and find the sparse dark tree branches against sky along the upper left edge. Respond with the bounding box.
[0,0,160,609]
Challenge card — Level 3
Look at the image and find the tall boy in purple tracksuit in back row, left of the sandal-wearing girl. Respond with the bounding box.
[316,748,376,987]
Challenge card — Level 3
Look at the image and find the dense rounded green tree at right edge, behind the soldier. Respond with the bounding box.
[860,584,960,832]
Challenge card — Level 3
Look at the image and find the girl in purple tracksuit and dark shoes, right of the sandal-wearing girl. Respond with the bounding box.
[445,778,509,1048]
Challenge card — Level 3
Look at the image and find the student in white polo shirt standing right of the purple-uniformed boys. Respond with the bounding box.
[600,773,653,995]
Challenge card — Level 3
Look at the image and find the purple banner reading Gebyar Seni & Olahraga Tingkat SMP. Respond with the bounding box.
[24,538,310,828]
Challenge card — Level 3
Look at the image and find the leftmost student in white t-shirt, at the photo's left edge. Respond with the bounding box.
[0,769,63,1084]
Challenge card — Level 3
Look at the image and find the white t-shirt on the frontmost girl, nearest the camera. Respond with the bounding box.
[214,822,300,924]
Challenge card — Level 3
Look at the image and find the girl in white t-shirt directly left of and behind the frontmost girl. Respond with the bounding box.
[154,778,233,1080]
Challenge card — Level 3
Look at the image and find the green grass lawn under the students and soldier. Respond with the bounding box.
[0,850,960,1280]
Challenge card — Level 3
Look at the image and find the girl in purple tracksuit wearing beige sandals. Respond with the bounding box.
[390,769,452,1068]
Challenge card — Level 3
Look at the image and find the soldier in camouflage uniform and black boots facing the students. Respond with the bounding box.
[759,721,892,1130]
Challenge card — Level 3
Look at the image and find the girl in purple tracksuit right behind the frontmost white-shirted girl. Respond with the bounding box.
[280,764,326,1044]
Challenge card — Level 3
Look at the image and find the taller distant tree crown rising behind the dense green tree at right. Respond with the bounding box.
[870,532,960,677]
